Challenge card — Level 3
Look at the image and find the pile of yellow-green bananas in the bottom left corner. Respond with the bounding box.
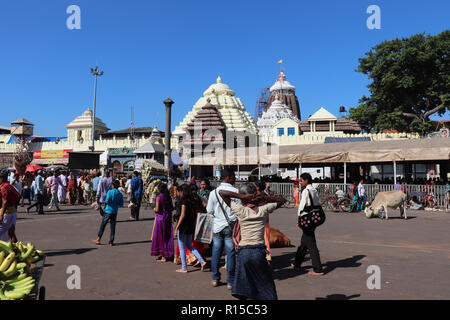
[0,241,44,300]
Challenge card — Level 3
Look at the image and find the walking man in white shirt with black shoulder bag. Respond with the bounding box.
[291,173,324,276]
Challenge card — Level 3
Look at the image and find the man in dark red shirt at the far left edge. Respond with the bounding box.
[0,172,20,242]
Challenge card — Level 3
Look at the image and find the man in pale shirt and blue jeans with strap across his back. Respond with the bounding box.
[206,169,240,290]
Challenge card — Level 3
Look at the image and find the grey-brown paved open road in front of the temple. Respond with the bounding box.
[17,202,450,300]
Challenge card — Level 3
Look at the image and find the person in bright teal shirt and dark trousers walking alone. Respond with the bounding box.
[92,180,123,247]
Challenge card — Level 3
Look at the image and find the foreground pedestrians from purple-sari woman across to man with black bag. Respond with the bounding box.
[151,169,324,300]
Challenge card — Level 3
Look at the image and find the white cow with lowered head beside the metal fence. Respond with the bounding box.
[364,190,408,220]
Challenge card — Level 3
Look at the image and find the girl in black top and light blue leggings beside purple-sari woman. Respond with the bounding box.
[175,184,206,273]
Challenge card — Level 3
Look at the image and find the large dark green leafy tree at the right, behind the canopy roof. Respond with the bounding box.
[349,30,450,134]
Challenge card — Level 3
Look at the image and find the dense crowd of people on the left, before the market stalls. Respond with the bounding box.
[0,170,143,246]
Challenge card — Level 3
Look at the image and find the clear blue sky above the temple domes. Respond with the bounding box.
[0,0,450,136]
